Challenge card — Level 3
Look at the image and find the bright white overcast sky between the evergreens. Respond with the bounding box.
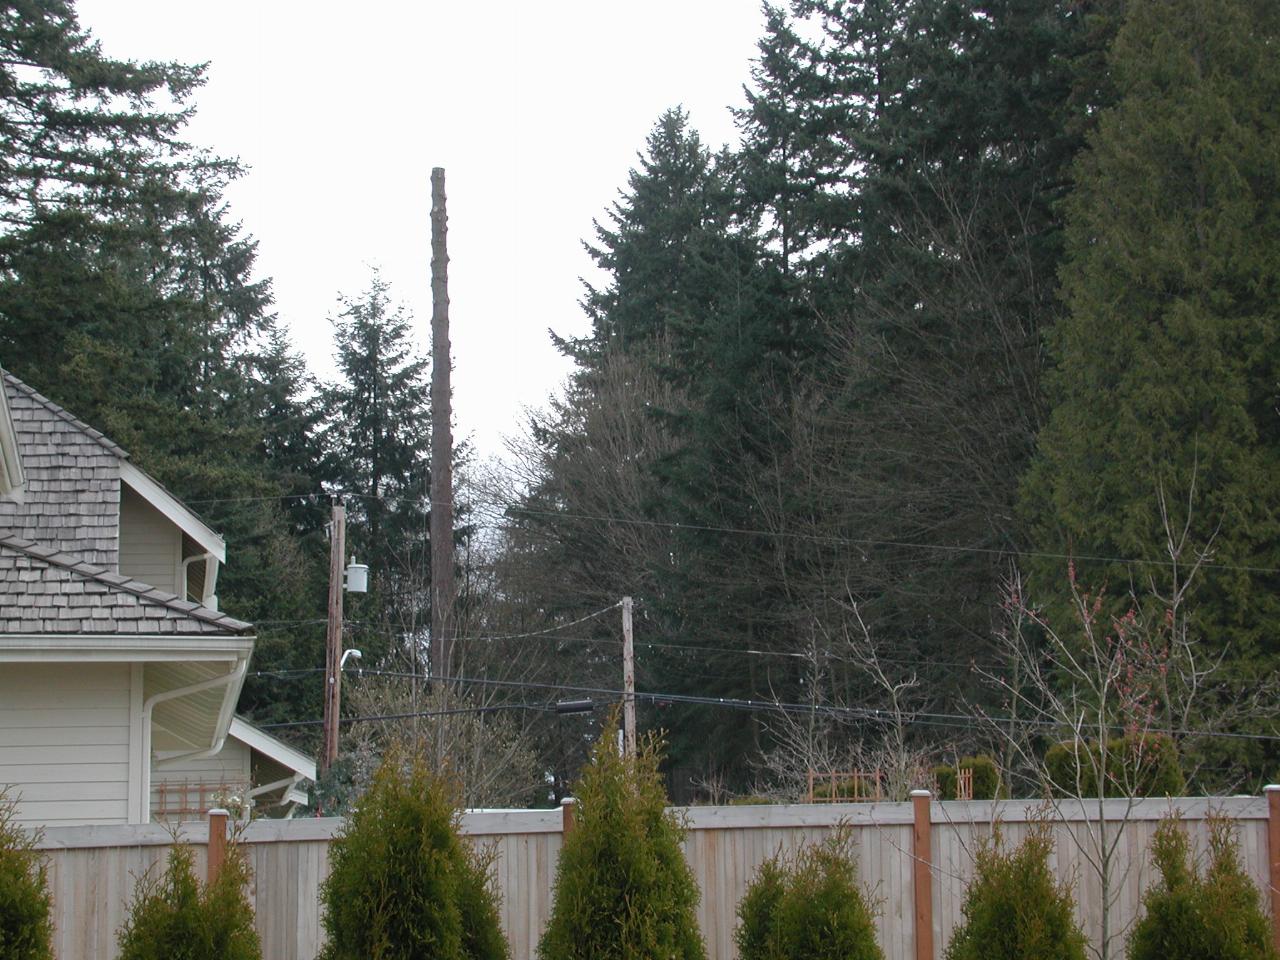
[77,0,763,457]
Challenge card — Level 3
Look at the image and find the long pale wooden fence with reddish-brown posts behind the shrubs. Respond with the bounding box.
[30,787,1280,960]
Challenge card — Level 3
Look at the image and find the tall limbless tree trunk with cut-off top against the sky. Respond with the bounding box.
[431,166,456,678]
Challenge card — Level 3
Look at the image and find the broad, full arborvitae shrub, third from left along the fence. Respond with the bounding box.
[320,751,509,960]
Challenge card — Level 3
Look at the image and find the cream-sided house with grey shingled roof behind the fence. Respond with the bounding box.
[0,374,315,826]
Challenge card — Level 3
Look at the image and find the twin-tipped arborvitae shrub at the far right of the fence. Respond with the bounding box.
[1128,818,1276,960]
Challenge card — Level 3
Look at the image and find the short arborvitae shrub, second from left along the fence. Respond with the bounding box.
[119,844,262,960]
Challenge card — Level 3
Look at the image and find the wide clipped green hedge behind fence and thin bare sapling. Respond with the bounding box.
[1044,733,1187,796]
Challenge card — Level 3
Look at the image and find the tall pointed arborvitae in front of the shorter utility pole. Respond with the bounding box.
[538,719,707,960]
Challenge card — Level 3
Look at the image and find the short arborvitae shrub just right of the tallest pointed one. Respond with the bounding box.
[733,829,884,960]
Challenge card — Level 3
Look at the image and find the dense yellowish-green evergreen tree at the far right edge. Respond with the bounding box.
[1023,0,1280,673]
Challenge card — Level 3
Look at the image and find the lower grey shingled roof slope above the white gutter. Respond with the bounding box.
[0,530,253,636]
